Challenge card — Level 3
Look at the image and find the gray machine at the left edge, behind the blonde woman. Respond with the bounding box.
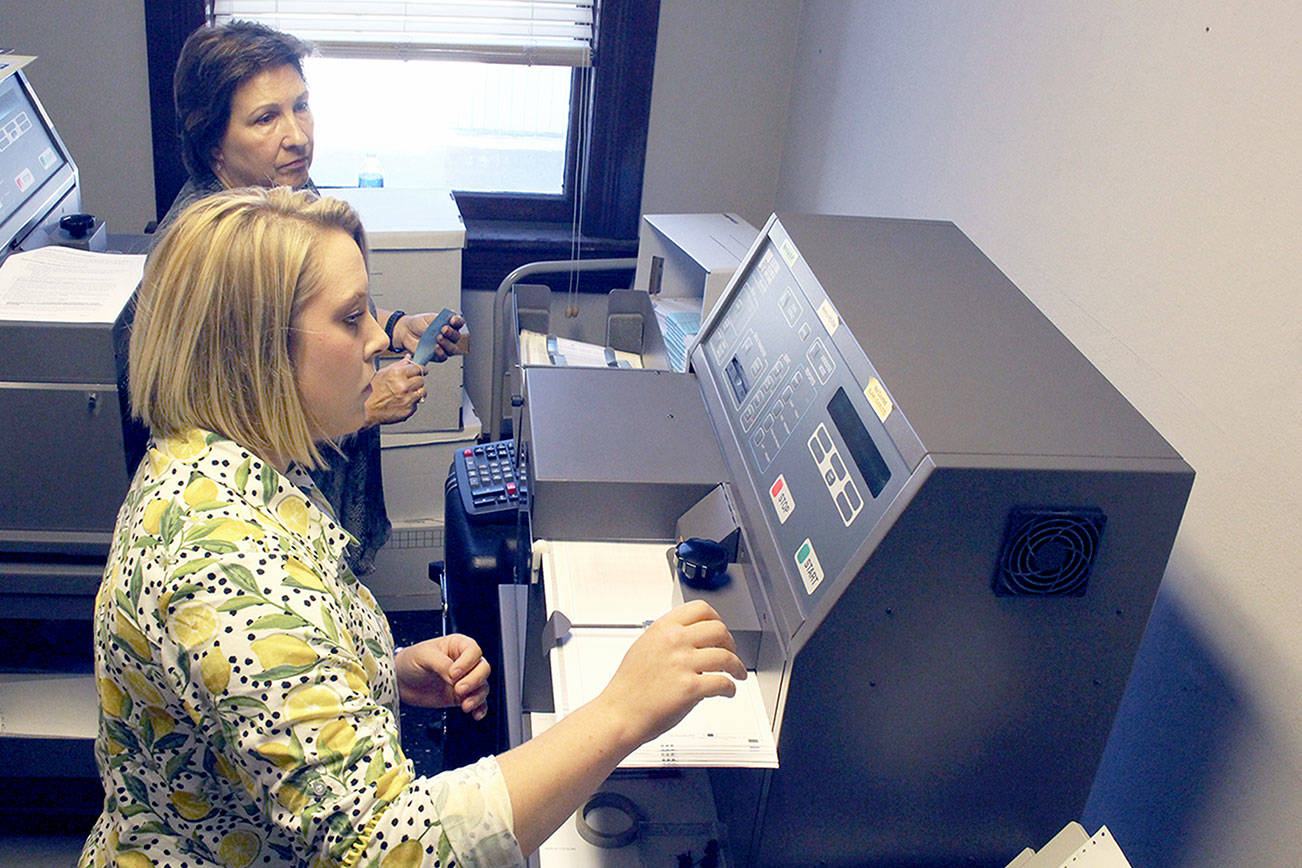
[0,72,128,619]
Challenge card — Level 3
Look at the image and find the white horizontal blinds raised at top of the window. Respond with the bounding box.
[212,0,596,66]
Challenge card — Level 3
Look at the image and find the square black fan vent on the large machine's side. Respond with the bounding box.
[993,508,1108,596]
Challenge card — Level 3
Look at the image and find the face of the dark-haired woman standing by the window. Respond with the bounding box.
[212,64,312,189]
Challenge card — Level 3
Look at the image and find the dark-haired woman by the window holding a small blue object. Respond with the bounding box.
[113,21,469,574]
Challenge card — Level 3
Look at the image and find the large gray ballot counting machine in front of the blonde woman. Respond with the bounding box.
[517,215,1194,865]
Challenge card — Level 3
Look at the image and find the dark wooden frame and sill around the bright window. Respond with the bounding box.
[145,0,660,256]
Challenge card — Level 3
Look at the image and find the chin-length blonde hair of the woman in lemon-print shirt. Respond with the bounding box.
[129,187,367,467]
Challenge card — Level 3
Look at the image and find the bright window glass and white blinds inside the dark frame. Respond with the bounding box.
[212,0,594,195]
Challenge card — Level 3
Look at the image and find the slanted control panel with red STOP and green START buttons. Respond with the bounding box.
[695,226,909,610]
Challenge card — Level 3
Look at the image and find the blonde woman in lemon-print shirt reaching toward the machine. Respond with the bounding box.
[81,187,745,867]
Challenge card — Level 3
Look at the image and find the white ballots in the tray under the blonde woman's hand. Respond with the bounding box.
[534,540,777,768]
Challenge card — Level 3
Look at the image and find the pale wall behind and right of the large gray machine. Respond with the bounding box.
[765,0,1302,865]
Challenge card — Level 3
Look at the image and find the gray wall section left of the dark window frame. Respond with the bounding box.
[0,0,156,233]
